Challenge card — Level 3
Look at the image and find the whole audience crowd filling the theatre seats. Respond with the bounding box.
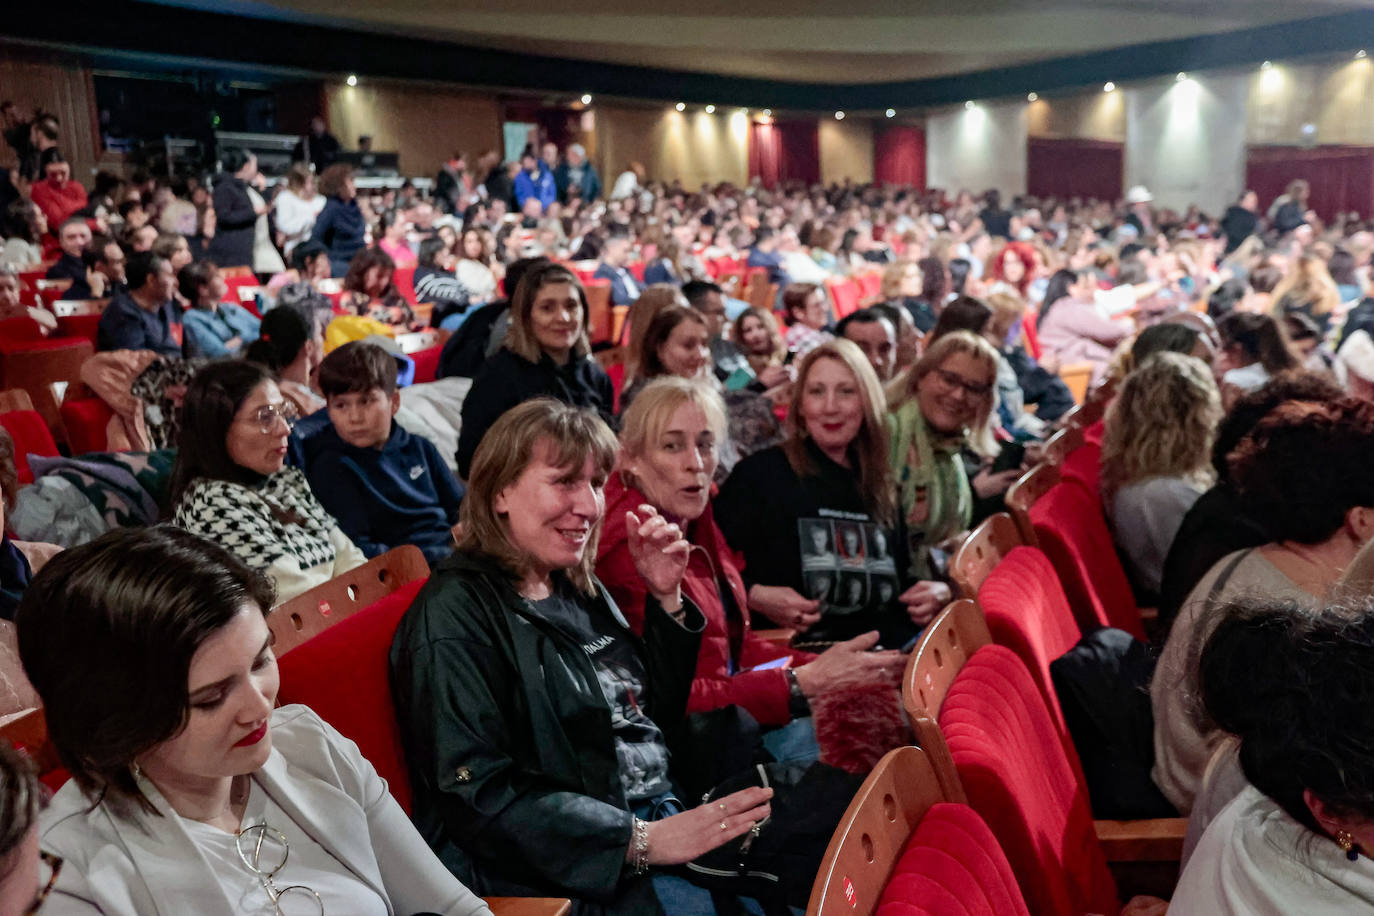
[0,106,1374,916]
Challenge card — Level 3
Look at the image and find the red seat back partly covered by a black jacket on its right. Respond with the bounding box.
[978,547,1081,773]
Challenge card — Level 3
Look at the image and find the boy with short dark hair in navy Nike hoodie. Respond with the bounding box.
[304,341,463,563]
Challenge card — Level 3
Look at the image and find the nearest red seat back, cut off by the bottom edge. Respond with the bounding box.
[874,802,1028,916]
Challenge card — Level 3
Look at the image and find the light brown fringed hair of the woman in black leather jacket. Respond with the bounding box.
[458,397,618,595]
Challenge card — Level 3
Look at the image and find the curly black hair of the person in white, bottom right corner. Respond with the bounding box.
[1198,599,1374,832]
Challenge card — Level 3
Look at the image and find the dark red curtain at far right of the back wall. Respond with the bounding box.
[1245,147,1374,221]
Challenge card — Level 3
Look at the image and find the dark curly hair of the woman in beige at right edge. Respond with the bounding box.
[1228,398,1374,544]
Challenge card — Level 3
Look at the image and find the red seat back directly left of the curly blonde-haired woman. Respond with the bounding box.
[1029,480,1145,639]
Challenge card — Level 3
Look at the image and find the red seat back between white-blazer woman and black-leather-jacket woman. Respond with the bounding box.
[267,580,417,813]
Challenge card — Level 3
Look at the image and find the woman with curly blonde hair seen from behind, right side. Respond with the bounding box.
[1099,352,1221,603]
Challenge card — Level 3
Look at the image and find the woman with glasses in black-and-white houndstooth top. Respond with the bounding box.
[172,361,367,602]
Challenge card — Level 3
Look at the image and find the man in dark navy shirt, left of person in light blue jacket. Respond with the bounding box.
[96,251,183,358]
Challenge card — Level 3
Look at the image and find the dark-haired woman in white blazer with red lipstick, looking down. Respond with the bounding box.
[16,526,491,916]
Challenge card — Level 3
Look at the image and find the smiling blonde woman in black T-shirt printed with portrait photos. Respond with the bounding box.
[716,339,929,648]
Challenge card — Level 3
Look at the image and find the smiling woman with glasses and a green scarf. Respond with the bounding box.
[889,331,1018,626]
